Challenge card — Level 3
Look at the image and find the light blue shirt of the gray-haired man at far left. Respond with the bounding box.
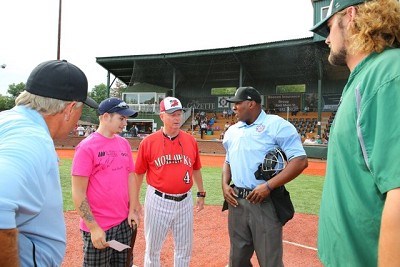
[0,106,66,266]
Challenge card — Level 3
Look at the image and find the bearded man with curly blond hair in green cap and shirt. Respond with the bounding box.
[311,0,400,267]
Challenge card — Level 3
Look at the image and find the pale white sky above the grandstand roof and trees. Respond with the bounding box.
[0,0,313,95]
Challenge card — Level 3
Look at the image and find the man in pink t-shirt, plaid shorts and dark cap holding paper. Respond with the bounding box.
[71,98,138,266]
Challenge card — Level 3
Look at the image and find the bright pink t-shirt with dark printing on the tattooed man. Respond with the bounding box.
[71,132,135,231]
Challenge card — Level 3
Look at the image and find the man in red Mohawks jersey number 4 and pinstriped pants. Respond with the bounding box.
[133,97,206,267]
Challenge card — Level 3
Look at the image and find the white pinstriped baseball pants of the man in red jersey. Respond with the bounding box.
[144,185,193,267]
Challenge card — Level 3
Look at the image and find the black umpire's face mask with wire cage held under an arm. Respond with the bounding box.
[255,147,287,180]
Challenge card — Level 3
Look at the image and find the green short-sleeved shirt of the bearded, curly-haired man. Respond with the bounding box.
[318,49,400,267]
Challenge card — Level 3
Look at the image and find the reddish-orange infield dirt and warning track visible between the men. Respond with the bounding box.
[57,150,325,267]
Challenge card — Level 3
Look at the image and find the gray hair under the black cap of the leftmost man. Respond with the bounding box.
[15,91,83,115]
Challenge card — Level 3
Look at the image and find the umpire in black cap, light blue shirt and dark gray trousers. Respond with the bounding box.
[222,87,308,267]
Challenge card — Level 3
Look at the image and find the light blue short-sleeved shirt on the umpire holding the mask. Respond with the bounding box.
[223,111,306,189]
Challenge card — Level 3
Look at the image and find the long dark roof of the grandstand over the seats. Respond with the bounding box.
[96,37,349,89]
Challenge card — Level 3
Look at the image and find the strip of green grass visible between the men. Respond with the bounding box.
[60,159,324,214]
